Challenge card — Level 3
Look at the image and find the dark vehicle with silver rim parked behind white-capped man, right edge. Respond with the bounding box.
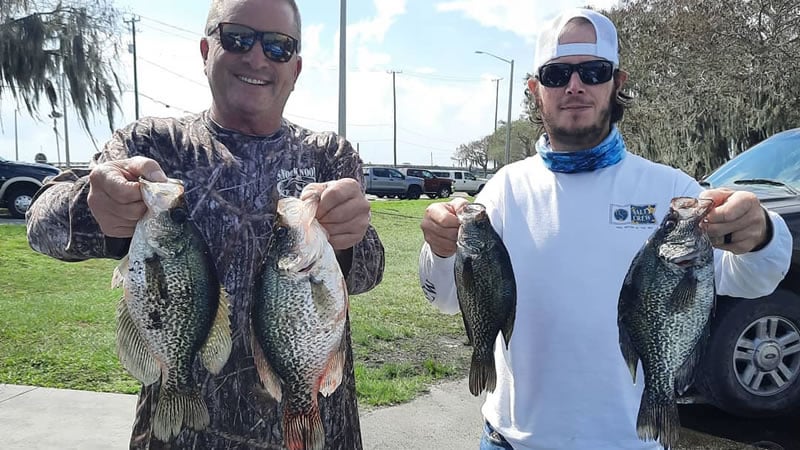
[695,128,800,417]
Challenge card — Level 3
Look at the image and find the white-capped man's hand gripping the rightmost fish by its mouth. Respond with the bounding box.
[700,188,770,254]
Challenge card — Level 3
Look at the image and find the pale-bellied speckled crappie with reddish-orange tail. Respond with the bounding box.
[252,188,349,450]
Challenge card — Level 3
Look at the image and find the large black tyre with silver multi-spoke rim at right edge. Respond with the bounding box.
[699,289,800,416]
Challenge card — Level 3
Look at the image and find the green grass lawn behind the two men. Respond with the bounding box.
[0,200,470,405]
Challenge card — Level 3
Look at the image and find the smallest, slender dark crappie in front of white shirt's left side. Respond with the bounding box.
[455,203,517,396]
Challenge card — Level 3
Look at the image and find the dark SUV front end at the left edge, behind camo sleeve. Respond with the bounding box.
[0,157,61,219]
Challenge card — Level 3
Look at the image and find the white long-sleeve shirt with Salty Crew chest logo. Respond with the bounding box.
[419,153,792,450]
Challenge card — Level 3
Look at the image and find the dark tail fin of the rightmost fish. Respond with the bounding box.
[636,390,681,450]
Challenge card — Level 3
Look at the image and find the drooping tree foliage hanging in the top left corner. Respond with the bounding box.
[0,0,121,130]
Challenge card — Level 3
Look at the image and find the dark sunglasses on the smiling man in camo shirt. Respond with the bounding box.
[208,22,298,63]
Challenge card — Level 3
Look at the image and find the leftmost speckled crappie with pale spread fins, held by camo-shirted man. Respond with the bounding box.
[113,179,231,442]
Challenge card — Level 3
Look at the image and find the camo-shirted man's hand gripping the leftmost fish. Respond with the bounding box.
[87,156,167,238]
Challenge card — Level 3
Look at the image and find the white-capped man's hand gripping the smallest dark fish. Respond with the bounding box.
[420,197,469,258]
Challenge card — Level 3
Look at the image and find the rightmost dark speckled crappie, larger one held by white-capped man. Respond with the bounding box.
[617,197,715,449]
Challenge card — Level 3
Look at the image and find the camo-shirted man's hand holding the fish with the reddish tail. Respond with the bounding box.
[300,178,370,250]
